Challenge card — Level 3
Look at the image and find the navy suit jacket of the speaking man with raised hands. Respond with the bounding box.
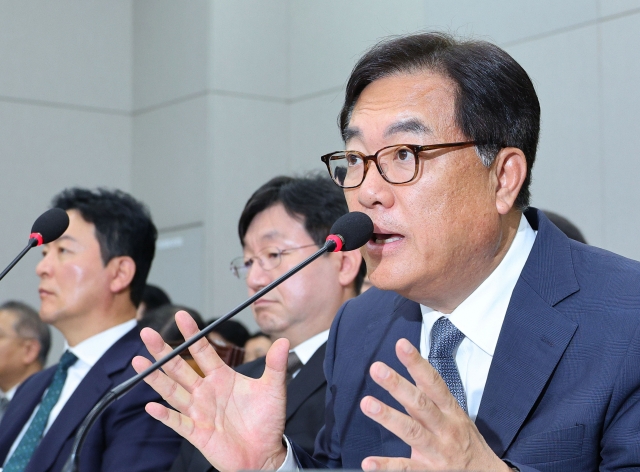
[294,209,640,471]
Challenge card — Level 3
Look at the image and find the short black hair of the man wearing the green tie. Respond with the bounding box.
[52,187,158,307]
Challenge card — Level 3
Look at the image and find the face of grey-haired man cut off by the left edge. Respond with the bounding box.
[0,310,31,391]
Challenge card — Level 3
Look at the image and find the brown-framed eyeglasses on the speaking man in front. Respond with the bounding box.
[320,141,477,188]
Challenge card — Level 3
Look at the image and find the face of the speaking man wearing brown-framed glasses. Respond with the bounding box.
[345,72,500,308]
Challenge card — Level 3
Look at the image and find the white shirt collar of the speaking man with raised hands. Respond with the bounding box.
[420,215,537,356]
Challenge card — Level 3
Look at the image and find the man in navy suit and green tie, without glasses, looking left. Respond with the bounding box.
[0,188,180,472]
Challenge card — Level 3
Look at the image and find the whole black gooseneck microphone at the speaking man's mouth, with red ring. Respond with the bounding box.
[62,211,373,472]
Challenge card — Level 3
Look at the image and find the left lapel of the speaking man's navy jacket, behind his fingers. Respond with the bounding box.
[363,295,422,457]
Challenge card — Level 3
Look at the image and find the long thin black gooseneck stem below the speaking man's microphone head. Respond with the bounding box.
[62,240,338,472]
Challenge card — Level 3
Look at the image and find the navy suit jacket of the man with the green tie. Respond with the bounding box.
[0,328,180,472]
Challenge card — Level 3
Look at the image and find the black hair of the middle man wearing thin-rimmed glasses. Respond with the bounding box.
[238,173,367,294]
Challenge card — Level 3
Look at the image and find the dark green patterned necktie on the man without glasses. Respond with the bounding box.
[4,351,78,472]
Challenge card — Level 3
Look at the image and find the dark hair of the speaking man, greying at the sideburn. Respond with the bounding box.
[338,32,540,210]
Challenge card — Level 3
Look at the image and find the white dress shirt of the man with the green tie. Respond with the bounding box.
[5,320,137,464]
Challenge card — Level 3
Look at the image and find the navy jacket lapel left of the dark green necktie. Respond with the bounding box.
[0,367,56,465]
